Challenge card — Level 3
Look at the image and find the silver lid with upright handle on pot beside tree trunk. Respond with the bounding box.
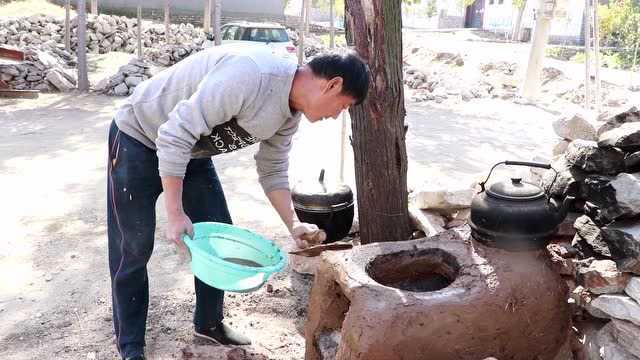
[291,170,353,208]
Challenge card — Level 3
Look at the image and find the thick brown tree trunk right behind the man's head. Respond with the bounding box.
[346,0,410,244]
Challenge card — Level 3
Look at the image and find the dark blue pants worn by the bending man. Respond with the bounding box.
[107,122,231,358]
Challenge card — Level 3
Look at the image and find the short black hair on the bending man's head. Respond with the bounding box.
[307,51,369,105]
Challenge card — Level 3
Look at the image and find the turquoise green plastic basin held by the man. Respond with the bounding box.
[183,222,287,292]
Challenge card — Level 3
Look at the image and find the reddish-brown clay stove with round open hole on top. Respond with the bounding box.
[305,231,570,360]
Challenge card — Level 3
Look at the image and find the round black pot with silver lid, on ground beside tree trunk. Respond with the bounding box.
[291,170,354,243]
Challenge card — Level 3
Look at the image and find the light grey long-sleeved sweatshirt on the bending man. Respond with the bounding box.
[115,45,300,193]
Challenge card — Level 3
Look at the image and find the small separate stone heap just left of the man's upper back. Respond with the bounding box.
[94,59,151,96]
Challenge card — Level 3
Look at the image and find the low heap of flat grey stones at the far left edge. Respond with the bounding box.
[0,45,76,92]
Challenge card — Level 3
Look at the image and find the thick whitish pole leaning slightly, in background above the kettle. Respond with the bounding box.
[522,0,552,101]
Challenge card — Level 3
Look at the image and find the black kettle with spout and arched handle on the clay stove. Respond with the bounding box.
[469,161,574,251]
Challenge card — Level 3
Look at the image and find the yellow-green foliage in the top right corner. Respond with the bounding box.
[598,0,640,66]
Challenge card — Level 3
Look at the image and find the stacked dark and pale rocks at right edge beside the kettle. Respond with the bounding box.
[543,107,640,359]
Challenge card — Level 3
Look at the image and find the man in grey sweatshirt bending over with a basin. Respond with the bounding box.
[108,45,369,359]
